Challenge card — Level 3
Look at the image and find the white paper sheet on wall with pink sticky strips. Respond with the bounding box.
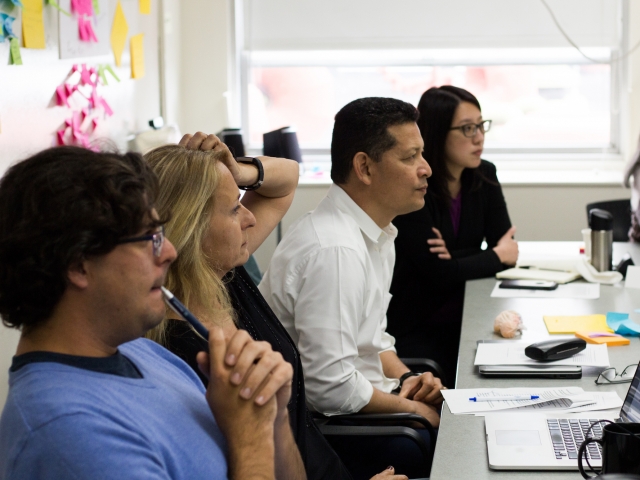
[58,0,113,59]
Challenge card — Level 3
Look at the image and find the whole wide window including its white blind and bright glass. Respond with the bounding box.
[242,0,628,162]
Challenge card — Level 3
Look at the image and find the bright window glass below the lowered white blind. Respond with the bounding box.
[247,52,616,151]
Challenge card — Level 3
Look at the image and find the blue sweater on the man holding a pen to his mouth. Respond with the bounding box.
[0,339,227,480]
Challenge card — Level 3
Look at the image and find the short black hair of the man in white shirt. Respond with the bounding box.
[331,97,418,185]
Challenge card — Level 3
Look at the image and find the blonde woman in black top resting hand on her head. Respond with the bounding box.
[145,132,406,480]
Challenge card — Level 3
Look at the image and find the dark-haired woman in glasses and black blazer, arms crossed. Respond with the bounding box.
[388,85,518,386]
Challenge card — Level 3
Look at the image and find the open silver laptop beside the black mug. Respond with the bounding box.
[484,367,640,470]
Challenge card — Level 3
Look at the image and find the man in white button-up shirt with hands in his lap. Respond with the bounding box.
[259,98,443,426]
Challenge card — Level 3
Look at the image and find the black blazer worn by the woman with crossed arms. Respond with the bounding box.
[387,160,511,342]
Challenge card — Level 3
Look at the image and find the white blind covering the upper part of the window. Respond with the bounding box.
[244,0,621,51]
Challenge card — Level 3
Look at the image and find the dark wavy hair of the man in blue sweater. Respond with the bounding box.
[0,147,162,328]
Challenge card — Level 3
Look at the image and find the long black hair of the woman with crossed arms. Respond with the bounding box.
[418,85,486,209]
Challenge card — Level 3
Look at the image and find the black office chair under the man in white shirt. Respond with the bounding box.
[313,358,445,480]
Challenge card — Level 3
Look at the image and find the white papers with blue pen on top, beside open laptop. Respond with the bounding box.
[442,387,622,415]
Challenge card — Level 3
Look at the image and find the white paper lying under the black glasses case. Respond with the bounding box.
[475,343,609,367]
